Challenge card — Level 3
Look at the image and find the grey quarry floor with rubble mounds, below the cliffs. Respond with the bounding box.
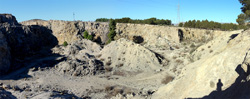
[0,39,193,99]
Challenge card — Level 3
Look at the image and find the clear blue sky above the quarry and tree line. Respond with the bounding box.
[0,0,241,23]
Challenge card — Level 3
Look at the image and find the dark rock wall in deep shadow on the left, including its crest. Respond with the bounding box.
[0,14,58,72]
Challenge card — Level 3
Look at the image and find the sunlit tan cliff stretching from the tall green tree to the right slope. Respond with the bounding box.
[116,23,224,46]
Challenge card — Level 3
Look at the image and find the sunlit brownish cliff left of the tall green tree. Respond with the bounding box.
[21,20,109,44]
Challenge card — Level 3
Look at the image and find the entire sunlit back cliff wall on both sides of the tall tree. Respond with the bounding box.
[21,20,229,46]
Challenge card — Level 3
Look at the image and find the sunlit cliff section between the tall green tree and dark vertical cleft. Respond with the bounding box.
[116,23,179,46]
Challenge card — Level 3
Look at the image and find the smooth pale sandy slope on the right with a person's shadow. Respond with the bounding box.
[153,30,250,99]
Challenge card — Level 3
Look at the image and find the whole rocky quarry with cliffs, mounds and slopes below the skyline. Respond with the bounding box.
[0,14,250,99]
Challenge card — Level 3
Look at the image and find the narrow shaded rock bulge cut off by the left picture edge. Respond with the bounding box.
[0,31,11,75]
